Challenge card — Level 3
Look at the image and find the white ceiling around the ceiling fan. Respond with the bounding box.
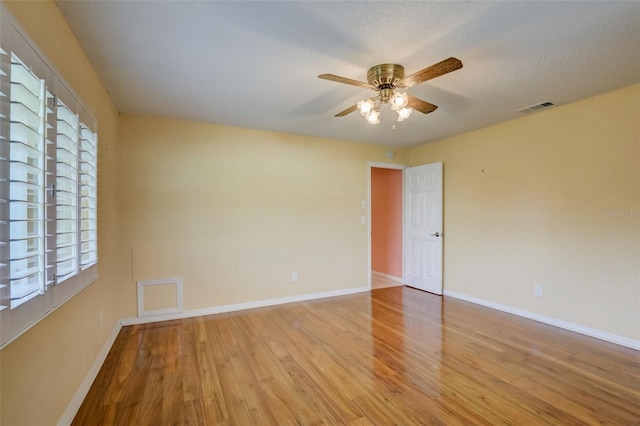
[57,0,640,147]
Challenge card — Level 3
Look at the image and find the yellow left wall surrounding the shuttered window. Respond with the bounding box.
[0,1,126,425]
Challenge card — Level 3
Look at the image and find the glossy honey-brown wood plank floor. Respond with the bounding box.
[73,287,640,426]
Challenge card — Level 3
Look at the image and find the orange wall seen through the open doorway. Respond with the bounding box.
[371,167,402,277]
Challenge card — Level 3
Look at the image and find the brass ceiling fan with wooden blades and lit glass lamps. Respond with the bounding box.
[318,58,462,124]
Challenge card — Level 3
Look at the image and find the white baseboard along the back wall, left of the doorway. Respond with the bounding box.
[120,286,371,326]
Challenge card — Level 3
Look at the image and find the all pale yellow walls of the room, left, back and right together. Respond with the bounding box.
[0,1,640,425]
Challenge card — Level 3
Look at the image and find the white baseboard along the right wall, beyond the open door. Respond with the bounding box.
[443,290,640,350]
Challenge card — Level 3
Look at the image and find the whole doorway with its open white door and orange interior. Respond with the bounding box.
[363,162,444,295]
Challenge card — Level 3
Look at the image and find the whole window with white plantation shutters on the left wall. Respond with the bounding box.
[0,10,98,346]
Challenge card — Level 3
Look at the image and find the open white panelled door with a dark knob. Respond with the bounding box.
[404,163,442,294]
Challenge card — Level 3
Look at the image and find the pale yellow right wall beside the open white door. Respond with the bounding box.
[410,86,640,340]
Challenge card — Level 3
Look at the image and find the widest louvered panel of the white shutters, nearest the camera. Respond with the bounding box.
[9,53,46,309]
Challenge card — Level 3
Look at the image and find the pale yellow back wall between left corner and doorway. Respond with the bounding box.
[118,115,402,310]
